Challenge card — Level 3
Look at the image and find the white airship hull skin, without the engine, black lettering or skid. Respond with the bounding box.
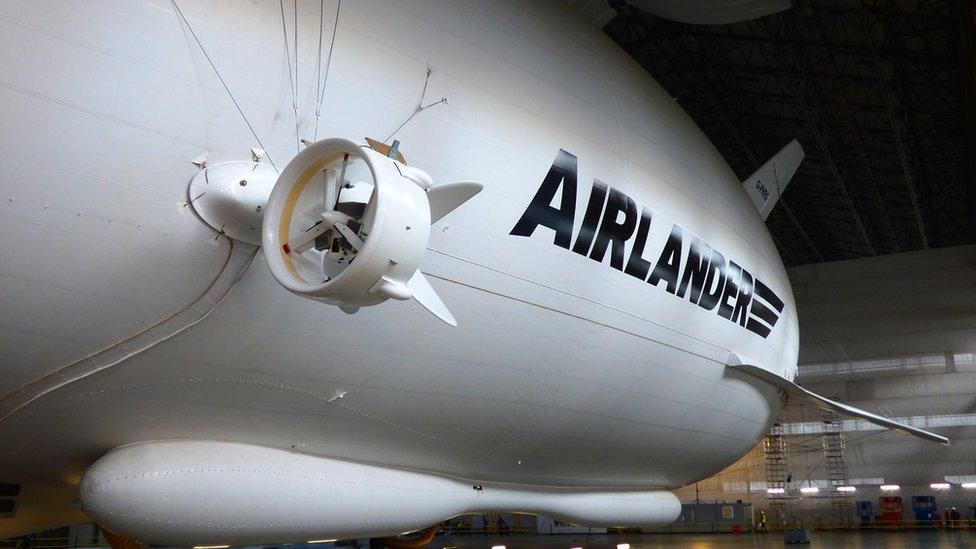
[0,0,798,543]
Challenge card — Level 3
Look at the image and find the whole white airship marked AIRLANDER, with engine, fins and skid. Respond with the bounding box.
[0,0,947,545]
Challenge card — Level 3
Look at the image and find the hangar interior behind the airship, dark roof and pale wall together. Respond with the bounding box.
[0,0,976,547]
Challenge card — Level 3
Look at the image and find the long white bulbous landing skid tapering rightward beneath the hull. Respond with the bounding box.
[79,440,681,547]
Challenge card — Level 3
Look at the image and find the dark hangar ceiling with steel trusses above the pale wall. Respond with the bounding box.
[604,0,976,266]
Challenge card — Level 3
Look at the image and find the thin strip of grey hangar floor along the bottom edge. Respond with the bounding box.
[438,531,976,549]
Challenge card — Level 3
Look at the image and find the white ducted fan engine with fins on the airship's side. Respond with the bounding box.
[262,138,484,326]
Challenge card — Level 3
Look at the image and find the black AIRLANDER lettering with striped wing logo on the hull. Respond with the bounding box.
[509,149,784,338]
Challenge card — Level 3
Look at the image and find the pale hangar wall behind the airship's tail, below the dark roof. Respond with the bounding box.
[678,246,976,520]
